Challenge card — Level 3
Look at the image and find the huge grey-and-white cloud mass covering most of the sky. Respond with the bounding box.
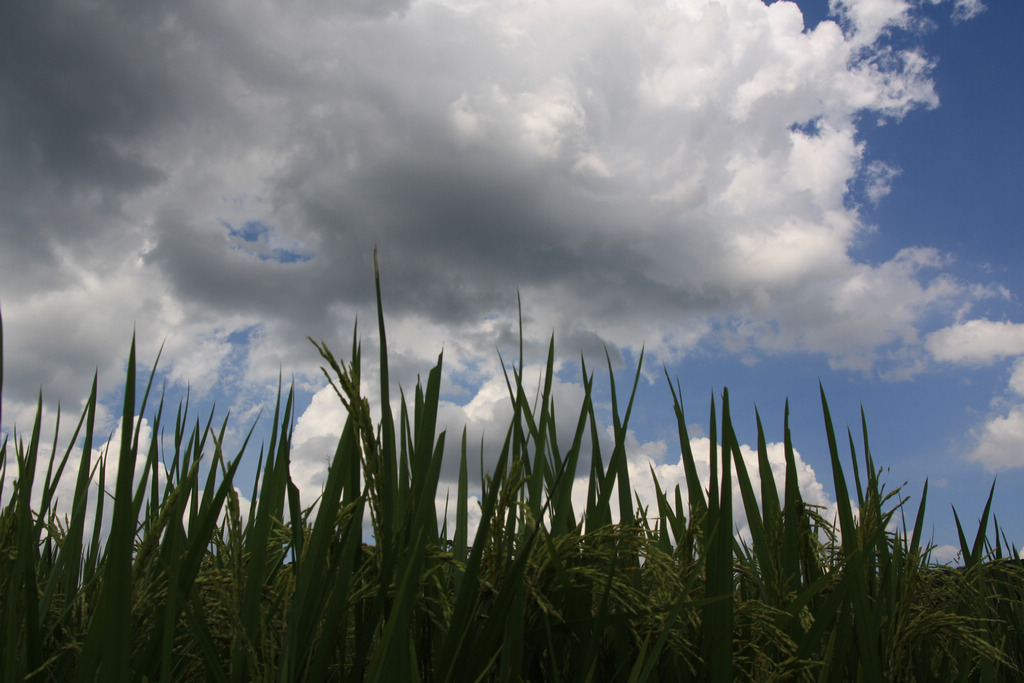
[0,0,991,458]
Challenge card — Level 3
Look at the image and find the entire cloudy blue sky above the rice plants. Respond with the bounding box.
[0,0,1024,559]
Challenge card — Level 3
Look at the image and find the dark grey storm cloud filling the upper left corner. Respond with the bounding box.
[0,2,315,274]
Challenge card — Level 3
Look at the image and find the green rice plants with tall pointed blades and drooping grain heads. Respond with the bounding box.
[0,264,1024,682]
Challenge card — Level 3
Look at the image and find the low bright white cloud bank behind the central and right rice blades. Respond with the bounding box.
[291,350,837,541]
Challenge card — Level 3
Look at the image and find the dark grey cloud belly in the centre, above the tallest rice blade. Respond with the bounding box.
[275,113,725,335]
